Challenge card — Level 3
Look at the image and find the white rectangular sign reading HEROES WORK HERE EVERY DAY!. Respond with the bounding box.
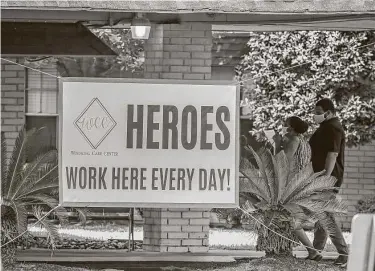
[59,78,239,208]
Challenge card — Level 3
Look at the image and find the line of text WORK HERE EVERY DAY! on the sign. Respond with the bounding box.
[66,167,230,191]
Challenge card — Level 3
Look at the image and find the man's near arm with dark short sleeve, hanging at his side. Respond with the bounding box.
[325,127,342,176]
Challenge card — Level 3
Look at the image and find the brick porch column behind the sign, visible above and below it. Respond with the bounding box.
[143,23,212,252]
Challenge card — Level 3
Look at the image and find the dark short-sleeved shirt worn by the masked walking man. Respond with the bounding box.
[309,117,345,187]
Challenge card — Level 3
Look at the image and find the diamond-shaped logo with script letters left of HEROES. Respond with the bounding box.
[74,98,117,149]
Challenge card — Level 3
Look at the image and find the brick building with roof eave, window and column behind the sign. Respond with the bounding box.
[1,0,375,252]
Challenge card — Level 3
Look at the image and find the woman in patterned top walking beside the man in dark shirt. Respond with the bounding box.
[281,116,322,261]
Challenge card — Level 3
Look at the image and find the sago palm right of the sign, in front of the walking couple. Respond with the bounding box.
[240,147,346,254]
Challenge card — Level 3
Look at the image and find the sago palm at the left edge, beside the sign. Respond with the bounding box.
[1,128,64,262]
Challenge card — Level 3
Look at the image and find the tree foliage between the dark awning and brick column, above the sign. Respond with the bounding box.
[26,29,144,77]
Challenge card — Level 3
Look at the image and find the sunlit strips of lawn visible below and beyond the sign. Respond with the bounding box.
[29,223,351,251]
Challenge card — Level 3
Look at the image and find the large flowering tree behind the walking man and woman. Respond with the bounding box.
[236,31,375,146]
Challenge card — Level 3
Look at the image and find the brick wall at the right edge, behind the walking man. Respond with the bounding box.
[340,141,375,230]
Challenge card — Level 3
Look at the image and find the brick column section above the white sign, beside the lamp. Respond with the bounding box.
[145,24,212,80]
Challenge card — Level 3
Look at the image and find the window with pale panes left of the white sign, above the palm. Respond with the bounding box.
[25,66,59,155]
